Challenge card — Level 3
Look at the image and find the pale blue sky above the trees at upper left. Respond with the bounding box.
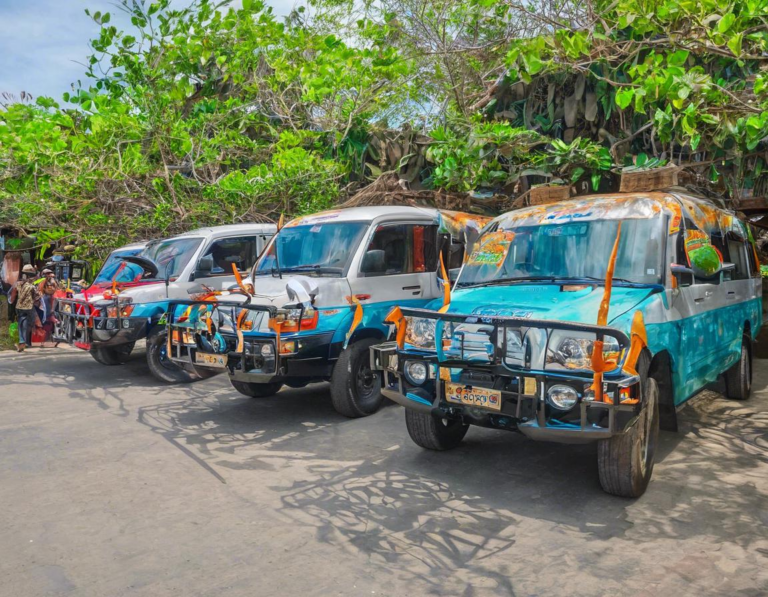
[0,0,296,101]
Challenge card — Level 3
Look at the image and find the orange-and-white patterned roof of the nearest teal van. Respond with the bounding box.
[494,189,736,231]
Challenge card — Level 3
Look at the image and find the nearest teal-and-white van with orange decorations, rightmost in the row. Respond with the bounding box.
[371,192,762,497]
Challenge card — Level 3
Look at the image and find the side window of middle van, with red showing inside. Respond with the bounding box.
[360,224,437,276]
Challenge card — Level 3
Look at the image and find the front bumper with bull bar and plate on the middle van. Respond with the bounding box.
[166,301,334,384]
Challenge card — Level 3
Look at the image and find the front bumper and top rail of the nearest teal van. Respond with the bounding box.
[371,309,641,443]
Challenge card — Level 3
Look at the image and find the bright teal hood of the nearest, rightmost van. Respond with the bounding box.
[449,284,655,325]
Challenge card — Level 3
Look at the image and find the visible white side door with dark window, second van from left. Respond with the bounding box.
[188,233,264,290]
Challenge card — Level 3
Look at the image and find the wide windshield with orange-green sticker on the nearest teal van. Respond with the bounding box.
[458,218,664,286]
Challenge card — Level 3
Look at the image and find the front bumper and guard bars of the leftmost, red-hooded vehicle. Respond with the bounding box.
[53,299,147,350]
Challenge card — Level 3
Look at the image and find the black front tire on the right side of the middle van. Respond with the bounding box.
[331,338,384,419]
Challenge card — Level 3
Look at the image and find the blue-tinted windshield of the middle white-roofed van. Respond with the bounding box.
[255,222,368,275]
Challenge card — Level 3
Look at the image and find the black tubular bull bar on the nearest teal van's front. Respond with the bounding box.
[371,308,642,443]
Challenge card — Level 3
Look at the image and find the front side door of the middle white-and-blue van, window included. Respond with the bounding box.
[350,222,440,317]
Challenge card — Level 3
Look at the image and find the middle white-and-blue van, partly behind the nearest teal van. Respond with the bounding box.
[168,207,489,417]
